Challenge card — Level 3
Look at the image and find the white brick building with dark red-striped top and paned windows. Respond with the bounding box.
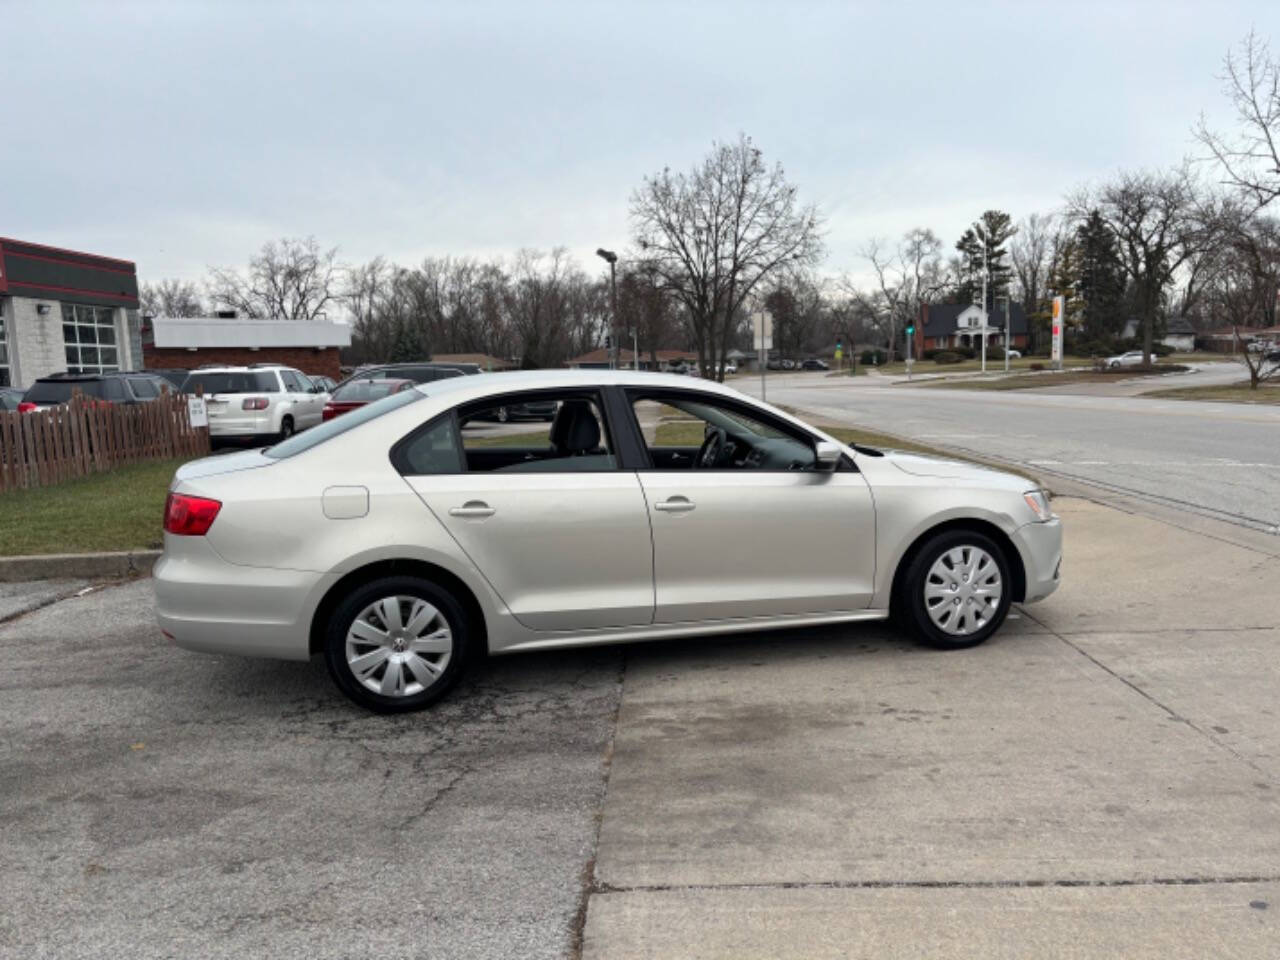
[0,238,142,387]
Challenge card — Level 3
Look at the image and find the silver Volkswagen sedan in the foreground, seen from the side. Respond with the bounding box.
[154,370,1062,712]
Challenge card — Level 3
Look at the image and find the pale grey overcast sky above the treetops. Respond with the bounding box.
[0,0,1280,280]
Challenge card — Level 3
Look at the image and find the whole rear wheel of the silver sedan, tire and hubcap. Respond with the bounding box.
[325,576,470,713]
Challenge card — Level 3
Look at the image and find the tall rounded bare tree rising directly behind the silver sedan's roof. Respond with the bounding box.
[631,136,822,380]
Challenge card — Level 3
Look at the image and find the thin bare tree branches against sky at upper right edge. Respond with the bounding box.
[1196,31,1280,211]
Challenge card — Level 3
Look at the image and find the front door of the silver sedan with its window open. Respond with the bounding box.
[631,392,876,623]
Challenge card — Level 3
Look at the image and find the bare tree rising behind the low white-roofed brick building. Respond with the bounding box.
[209,237,343,320]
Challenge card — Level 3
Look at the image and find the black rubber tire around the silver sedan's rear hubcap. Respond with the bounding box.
[324,576,472,713]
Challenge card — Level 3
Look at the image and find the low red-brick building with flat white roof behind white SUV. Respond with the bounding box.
[142,316,351,380]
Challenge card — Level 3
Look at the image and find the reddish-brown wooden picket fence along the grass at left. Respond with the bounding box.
[0,392,209,492]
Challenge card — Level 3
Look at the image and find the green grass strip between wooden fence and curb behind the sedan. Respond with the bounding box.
[0,460,186,557]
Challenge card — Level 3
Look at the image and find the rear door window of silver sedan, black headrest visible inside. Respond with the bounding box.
[458,392,617,474]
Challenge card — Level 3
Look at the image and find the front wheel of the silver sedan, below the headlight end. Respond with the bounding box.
[899,530,1012,649]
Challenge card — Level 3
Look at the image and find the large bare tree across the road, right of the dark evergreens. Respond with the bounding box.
[1070,168,1204,364]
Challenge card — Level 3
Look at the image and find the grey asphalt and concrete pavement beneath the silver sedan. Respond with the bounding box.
[0,499,1280,960]
